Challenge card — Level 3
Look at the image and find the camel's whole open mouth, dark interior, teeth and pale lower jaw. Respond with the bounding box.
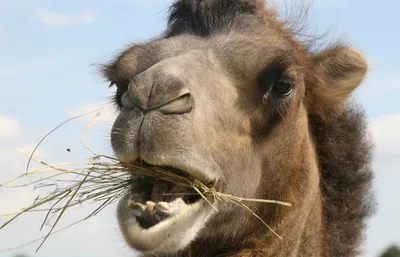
[117,160,216,254]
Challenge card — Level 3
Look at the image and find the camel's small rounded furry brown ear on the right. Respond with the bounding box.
[309,46,368,118]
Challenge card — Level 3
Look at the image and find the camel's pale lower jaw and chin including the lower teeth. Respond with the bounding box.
[117,186,215,255]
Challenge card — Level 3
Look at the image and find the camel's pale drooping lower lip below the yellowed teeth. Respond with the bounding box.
[117,193,215,254]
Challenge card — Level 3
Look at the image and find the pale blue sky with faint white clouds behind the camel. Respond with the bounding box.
[0,0,400,257]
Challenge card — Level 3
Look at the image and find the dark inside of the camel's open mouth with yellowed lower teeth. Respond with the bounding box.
[126,160,202,229]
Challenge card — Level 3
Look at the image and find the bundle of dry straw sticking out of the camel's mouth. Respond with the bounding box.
[0,107,291,250]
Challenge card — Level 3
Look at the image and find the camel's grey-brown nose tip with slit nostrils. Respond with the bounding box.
[125,68,192,114]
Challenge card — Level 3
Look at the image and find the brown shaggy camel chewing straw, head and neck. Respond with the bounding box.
[103,0,374,257]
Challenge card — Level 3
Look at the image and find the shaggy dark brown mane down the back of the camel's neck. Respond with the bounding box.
[310,106,375,256]
